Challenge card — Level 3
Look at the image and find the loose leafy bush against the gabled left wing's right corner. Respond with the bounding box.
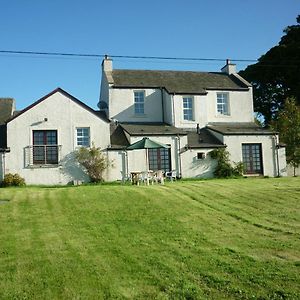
[75,144,112,183]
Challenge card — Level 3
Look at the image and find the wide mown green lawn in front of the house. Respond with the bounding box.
[0,178,300,299]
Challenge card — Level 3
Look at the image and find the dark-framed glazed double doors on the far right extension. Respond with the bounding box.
[242,144,263,174]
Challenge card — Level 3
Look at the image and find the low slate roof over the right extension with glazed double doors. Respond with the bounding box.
[207,123,276,135]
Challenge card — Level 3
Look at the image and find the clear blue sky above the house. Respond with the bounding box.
[0,0,300,110]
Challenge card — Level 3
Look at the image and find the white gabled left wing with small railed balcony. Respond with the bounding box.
[0,88,110,184]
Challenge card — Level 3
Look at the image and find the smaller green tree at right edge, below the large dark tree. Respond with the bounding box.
[273,98,300,176]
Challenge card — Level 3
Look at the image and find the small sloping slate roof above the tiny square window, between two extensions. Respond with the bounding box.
[187,128,225,148]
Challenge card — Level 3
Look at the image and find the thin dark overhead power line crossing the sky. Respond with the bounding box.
[0,50,257,62]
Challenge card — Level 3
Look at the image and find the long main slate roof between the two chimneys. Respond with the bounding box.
[107,70,249,94]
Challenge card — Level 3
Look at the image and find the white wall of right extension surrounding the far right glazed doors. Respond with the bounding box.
[224,135,286,177]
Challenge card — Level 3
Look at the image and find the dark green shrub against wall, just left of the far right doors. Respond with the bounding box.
[210,148,244,178]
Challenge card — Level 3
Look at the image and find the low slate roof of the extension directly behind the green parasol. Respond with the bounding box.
[120,123,186,136]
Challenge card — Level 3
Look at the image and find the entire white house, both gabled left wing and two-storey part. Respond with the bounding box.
[0,57,286,184]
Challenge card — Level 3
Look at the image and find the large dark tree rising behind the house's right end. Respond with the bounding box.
[239,15,300,125]
